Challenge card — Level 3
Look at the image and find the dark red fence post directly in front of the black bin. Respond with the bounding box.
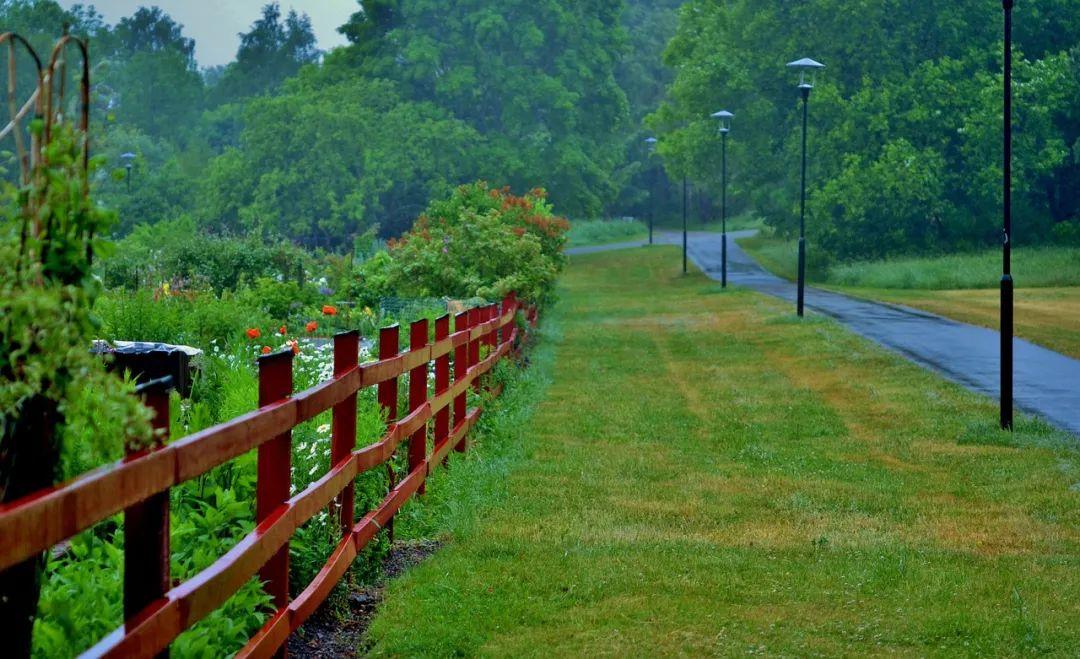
[124,377,173,657]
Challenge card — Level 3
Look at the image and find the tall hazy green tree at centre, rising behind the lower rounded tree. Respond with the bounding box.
[327,0,629,215]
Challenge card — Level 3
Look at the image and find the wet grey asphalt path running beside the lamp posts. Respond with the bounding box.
[567,231,1080,436]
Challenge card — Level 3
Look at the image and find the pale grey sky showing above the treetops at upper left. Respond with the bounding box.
[59,0,360,67]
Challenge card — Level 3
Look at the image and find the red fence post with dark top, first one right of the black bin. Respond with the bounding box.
[255,350,293,622]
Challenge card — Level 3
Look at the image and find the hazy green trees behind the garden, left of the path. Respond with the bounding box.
[0,0,678,246]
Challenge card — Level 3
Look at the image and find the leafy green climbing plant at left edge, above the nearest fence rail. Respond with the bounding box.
[0,124,149,462]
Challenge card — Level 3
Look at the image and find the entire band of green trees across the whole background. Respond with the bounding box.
[0,0,1080,258]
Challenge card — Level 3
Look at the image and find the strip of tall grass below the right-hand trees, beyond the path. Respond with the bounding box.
[826,247,1080,291]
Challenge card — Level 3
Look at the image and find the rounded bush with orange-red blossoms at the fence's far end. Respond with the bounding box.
[378,183,569,302]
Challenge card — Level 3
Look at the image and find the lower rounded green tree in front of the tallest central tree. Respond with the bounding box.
[199,69,477,240]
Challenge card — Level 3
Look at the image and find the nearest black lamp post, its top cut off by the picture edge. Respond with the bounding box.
[1000,0,1013,430]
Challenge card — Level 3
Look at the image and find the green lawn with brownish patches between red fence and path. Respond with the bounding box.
[366,247,1080,656]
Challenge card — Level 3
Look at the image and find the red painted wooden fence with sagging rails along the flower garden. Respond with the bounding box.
[0,296,537,657]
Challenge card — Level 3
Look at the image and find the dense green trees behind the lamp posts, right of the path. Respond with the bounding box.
[649,0,1080,259]
